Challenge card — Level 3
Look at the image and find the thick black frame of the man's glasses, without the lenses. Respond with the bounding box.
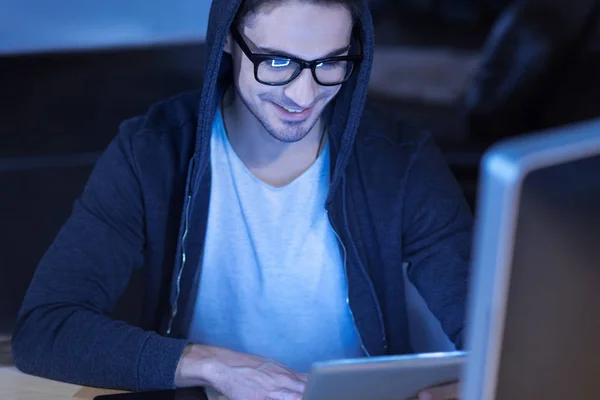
[231,26,364,86]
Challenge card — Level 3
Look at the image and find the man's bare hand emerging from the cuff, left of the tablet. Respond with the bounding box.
[175,345,307,400]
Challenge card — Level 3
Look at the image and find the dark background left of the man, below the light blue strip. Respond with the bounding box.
[0,44,204,335]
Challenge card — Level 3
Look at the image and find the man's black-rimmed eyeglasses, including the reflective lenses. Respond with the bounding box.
[231,27,363,86]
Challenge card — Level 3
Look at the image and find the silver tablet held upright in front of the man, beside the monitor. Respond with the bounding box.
[303,351,466,400]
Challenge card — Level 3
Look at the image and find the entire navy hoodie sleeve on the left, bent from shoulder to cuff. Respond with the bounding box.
[12,122,187,390]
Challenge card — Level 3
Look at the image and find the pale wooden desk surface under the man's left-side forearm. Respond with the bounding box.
[0,367,224,400]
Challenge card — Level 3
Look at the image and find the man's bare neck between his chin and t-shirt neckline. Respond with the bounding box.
[222,88,327,186]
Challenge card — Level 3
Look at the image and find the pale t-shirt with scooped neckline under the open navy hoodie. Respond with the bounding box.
[189,111,364,372]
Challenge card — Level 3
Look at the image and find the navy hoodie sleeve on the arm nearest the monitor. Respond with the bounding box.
[403,134,472,349]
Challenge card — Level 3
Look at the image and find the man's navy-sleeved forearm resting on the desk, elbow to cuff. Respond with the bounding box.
[13,305,187,390]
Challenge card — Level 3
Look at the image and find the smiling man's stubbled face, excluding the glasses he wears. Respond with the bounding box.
[226,1,352,143]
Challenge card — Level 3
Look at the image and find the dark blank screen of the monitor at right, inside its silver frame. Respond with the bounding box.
[495,156,600,400]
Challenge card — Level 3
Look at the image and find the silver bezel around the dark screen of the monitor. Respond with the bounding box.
[461,119,600,400]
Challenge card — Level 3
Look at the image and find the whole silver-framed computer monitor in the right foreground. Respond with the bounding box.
[461,120,600,400]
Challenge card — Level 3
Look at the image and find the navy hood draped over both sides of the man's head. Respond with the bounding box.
[194,0,374,201]
